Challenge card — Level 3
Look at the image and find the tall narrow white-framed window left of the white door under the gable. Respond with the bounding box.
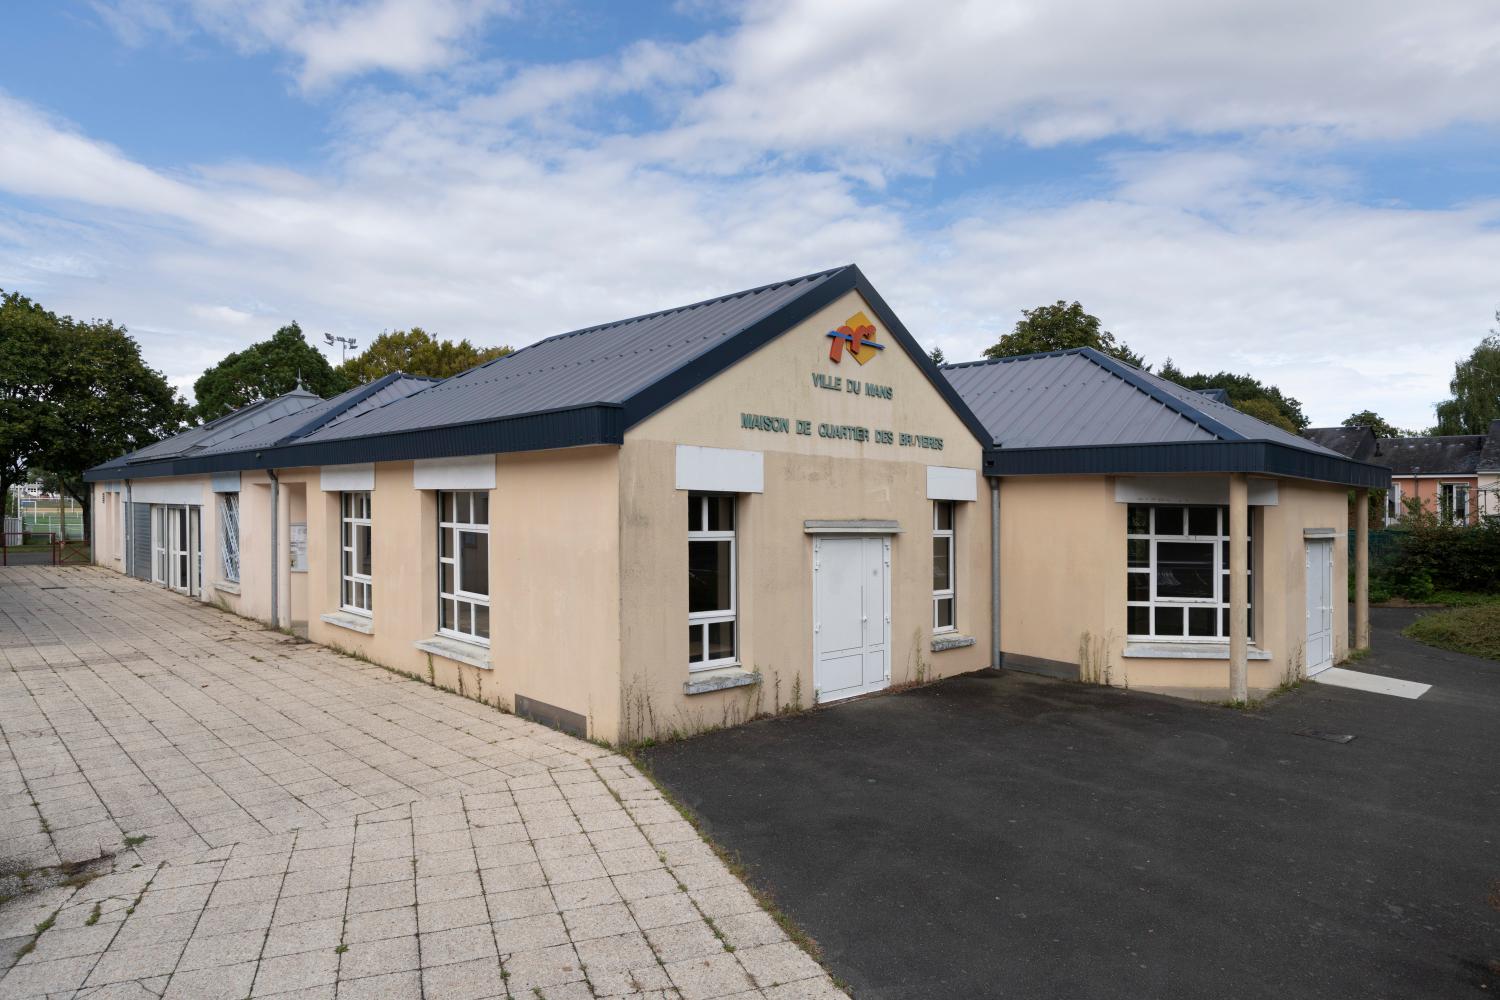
[687,493,738,670]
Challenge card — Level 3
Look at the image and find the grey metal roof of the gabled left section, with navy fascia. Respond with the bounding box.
[89,264,989,478]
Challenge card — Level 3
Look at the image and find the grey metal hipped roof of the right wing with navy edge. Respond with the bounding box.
[944,348,1389,487]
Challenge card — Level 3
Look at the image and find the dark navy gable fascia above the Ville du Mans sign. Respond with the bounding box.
[624,264,992,445]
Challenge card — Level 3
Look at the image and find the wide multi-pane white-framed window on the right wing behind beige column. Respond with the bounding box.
[1125,504,1256,642]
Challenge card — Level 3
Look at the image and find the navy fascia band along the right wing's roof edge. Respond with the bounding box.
[984,441,1391,490]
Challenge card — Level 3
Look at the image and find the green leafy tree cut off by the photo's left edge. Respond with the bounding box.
[0,291,63,513]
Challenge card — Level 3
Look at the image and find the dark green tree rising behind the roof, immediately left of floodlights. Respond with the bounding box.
[192,322,350,421]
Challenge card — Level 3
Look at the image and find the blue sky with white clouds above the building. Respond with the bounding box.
[0,0,1500,427]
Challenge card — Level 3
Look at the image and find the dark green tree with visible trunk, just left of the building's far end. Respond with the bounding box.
[36,318,189,532]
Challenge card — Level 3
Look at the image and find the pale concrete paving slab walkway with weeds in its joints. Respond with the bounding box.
[0,567,843,1000]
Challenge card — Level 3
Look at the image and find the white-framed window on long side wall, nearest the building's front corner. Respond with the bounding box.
[438,490,489,646]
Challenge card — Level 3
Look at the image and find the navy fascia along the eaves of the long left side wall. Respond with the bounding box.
[84,403,626,483]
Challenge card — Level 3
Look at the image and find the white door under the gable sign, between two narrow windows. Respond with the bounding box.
[813,538,891,702]
